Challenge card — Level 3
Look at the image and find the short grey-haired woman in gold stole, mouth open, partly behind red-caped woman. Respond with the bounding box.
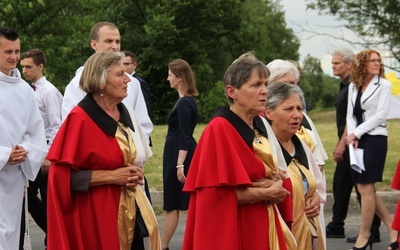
[265,83,326,250]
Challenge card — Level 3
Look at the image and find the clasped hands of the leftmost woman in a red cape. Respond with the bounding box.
[111,164,144,190]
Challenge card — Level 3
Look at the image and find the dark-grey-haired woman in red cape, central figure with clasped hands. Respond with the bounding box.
[183,55,296,250]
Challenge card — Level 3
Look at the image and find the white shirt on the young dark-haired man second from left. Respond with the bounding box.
[34,76,63,147]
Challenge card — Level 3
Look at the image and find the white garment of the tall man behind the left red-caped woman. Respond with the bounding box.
[62,66,153,136]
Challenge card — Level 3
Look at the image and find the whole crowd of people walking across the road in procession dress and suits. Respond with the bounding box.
[0,22,400,250]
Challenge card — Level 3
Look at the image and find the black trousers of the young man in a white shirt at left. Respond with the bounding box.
[19,171,48,250]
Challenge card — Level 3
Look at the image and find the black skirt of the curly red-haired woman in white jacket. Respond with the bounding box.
[353,134,388,184]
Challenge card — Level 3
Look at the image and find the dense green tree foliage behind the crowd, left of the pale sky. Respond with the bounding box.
[0,0,300,124]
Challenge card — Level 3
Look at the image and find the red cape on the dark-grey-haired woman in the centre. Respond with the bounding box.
[183,117,286,250]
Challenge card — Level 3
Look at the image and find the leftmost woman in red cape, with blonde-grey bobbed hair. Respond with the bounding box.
[47,52,161,250]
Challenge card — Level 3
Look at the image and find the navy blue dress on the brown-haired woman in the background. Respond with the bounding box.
[163,96,198,211]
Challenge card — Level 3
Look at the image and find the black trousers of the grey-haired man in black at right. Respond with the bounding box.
[327,147,381,232]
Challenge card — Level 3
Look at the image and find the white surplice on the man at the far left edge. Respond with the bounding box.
[0,69,47,250]
